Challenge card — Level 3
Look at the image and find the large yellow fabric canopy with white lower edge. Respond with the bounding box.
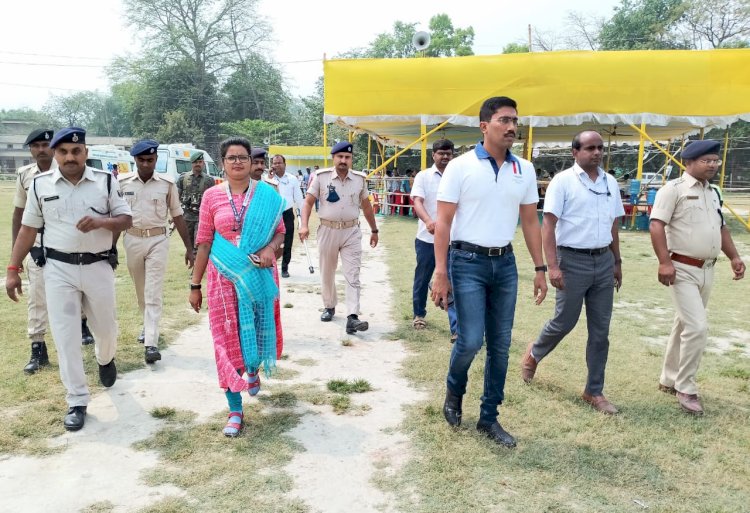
[324,49,750,145]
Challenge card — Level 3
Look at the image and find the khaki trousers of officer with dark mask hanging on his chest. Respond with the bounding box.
[317,225,362,315]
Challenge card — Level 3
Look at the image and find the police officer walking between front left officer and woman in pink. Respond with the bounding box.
[118,139,195,363]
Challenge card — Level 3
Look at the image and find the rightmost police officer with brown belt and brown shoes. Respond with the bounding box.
[650,140,745,415]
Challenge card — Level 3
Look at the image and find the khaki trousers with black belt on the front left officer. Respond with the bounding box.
[44,260,117,406]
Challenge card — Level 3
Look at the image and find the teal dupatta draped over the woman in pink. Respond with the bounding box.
[209,181,285,376]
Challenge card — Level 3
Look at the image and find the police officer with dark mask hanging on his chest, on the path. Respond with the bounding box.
[299,141,378,333]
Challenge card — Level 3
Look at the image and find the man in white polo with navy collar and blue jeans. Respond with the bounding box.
[432,96,547,447]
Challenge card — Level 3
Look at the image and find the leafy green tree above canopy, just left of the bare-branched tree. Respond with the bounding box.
[598,0,690,50]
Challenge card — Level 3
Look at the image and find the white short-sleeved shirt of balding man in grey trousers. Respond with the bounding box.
[544,164,625,249]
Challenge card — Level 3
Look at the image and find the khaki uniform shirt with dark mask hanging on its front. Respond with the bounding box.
[307,168,368,221]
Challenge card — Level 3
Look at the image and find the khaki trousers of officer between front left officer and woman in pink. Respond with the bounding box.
[123,233,169,347]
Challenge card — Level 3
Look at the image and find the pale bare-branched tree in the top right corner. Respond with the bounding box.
[684,0,750,48]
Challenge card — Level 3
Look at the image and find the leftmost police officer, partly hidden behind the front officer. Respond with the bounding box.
[12,128,94,374]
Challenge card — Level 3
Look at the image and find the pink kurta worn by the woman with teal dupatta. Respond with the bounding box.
[195,185,285,392]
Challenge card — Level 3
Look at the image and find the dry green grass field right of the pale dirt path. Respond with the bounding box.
[375,218,750,513]
